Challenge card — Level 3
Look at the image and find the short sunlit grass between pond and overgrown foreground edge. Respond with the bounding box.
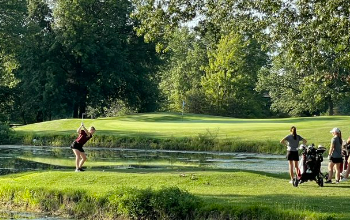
[0,170,350,219]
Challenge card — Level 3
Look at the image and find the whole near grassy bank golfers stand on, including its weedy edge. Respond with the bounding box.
[0,170,350,219]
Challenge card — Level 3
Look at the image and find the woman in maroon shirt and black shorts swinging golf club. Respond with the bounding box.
[71,123,96,172]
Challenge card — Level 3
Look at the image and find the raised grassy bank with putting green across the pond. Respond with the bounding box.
[13,113,350,153]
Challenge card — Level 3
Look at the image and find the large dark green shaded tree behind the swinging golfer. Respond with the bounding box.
[54,0,161,117]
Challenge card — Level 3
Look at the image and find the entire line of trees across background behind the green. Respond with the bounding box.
[0,0,350,123]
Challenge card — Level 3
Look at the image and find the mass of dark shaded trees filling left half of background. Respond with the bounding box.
[0,0,158,123]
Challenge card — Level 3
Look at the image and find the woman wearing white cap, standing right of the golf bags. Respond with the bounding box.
[325,128,343,183]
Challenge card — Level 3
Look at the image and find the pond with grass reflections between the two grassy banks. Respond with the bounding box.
[0,146,327,175]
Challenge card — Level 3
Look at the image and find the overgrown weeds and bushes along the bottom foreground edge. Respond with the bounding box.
[0,185,334,220]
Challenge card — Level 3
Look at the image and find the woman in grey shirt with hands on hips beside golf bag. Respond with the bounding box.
[280,126,306,183]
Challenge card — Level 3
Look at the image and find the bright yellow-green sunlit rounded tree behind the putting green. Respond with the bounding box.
[202,32,267,117]
